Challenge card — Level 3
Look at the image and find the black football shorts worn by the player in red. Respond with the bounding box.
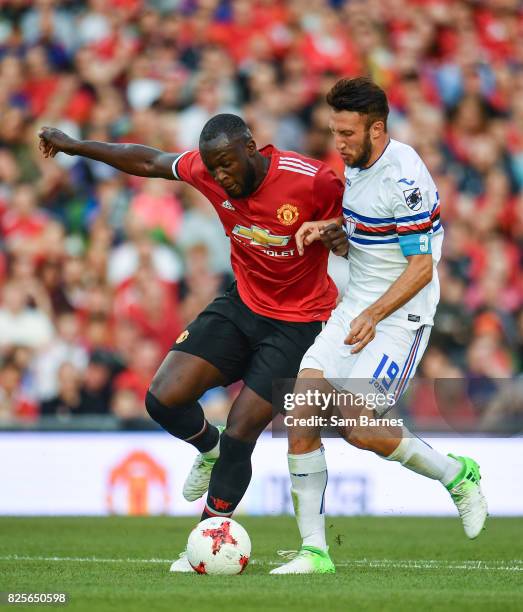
[171,283,323,402]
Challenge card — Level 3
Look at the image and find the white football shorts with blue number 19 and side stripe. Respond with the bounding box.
[300,303,432,414]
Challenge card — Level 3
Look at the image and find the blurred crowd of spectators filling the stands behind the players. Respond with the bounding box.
[0,0,523,427]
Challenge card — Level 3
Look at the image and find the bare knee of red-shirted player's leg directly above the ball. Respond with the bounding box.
[226,385,273,442]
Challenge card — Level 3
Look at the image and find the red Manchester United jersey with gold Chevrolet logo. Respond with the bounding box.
[173,145,343,322]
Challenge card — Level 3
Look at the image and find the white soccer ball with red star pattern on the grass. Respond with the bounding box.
[187,517,251,575]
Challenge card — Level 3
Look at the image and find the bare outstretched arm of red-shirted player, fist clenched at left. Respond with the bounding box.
[38,127,179,180]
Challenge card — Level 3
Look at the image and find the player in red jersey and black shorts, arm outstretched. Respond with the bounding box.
[39,114,343,571]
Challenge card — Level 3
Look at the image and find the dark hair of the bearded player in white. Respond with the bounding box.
[327,77,389,131]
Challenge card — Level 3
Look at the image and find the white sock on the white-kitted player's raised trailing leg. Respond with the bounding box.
[385,428,462,485]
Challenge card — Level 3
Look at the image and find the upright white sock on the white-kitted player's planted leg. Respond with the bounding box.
[288,446,327,550]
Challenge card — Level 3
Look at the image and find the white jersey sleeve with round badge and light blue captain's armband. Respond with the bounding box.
[389,166,438,257]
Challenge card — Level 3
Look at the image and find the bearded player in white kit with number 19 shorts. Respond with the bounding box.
[271,78,487,574]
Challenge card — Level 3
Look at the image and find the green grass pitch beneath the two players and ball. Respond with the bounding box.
[0,517,523,612]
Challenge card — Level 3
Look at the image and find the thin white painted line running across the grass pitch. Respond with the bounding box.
[0,555,523,572]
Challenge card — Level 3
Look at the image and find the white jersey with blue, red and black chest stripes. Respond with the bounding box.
[342,140,443,329]
